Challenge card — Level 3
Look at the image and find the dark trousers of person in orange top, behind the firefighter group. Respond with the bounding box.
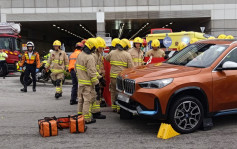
[70,69,78,101]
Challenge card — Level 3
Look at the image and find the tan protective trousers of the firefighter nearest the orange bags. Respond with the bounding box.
[78,85,94,122]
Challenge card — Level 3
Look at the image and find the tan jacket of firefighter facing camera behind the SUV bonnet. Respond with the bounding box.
[128,47,144,67]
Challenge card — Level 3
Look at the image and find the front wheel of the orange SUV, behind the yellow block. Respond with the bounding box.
[169,96,204,133]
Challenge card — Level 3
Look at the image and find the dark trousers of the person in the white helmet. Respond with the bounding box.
[24,64,36,88]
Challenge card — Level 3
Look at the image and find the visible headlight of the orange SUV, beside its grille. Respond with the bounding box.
[138,78,174,88]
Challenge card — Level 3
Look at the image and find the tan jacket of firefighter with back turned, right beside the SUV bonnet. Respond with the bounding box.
[105,49,134,78]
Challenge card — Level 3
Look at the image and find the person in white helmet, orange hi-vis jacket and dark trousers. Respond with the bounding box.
[19,41,40,92]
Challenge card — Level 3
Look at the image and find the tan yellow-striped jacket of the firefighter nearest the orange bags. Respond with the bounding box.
[75,51,99,86]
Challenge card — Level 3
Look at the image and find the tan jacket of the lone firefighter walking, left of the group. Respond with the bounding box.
[45,50,69,74]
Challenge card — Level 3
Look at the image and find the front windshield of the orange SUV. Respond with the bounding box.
[166,43,228,68]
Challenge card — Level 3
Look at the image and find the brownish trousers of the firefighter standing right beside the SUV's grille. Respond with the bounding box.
[110,78,120,112]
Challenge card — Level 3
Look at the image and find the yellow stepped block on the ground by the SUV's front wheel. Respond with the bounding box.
[157,123,180,139]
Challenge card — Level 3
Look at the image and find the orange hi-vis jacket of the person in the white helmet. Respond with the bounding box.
[19,52,40,68]
